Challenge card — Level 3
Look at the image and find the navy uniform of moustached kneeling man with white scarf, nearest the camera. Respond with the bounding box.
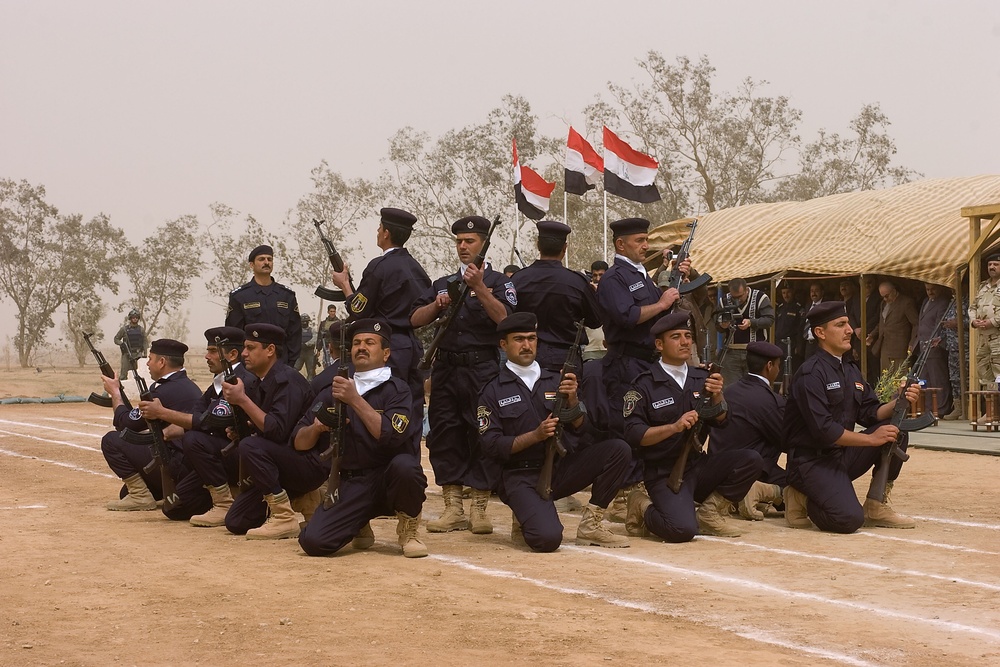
[292,377,427,556]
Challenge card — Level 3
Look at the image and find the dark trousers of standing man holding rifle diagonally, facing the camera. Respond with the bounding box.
[427,361,500,490]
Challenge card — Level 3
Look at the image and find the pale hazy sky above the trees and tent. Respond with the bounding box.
[0,0,1000,354]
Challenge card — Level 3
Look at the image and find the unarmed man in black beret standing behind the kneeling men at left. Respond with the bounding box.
[226,245,302,366]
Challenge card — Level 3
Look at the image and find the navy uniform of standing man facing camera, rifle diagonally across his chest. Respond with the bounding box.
[413,268,518,490]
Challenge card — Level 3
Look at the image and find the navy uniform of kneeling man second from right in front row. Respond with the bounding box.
[624,366,762,542]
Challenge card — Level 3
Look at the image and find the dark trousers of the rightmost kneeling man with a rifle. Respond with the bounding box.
[788,430,908,533]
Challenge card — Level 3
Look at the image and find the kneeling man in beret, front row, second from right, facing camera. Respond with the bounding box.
[623,310,762,542]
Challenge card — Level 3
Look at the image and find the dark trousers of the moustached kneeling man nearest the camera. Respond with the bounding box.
[299,454,427,556]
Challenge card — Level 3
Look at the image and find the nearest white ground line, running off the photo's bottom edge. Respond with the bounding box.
[430,554,874,667]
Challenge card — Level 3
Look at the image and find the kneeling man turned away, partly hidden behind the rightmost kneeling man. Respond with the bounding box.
[708,341,785,521]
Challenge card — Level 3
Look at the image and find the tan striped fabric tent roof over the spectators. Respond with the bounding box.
[649,175,1000,285]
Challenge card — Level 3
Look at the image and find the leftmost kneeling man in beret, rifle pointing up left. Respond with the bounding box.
[101,338,201,511]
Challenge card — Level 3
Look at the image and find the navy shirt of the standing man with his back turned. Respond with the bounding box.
[511,259,602,371]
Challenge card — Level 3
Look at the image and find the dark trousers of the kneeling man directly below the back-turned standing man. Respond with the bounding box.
[497,439,632,552]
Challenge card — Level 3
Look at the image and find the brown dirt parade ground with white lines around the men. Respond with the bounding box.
[0,368,1000,666]
